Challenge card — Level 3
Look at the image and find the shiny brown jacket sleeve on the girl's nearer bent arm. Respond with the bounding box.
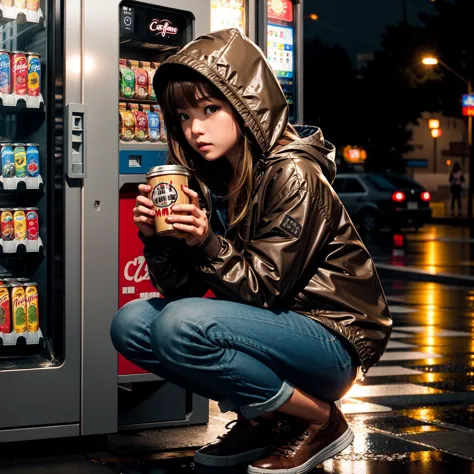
[188,160,334,308]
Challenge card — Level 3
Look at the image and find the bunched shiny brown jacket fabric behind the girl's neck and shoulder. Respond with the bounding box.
[284,125,337,184]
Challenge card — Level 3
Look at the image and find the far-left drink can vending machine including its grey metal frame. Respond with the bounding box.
[0,0,86,442]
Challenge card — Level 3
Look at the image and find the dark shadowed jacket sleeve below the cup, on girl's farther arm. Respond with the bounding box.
[140,236,209,299]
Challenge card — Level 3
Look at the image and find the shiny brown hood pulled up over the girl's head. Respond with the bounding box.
[153,28,288,154]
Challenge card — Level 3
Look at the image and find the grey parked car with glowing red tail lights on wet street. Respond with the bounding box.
[333,173,431,232]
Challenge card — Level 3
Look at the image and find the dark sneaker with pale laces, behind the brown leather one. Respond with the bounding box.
[194,415,278,466]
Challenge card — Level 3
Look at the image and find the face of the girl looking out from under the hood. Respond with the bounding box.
[177,92,243,165]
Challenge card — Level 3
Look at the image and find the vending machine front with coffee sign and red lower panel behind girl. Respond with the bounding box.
[118,1,194,375]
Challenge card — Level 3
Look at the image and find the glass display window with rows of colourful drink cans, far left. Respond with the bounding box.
[0,0,64,371]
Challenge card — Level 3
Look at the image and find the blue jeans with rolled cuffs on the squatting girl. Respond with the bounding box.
[111,298,356,419]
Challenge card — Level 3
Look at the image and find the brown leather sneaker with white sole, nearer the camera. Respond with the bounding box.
[247,403,354,474]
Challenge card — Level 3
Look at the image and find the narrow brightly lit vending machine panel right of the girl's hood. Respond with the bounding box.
[267,0,296,120]
